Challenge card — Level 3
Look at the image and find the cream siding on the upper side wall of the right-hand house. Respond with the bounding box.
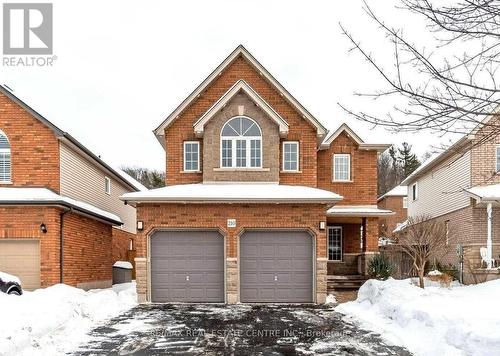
[408,152,471,217]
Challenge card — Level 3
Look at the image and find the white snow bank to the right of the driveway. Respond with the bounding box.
[335,279,500,356]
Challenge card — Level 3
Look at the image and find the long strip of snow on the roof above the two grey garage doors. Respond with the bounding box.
[120,183,343,203]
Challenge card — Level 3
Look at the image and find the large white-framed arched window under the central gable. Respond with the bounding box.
[220,116,262,168]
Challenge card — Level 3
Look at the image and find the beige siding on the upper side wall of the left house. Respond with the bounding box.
[60,143,136,234]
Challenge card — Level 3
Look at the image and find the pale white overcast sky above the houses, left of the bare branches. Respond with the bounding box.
[0,0,454,170]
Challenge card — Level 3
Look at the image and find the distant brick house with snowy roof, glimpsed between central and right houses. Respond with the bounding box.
[377,185,408,240]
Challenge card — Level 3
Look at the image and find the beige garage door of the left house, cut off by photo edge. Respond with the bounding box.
[0,239,40,290]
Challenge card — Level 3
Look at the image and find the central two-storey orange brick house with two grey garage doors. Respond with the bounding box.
[122,46,391,303]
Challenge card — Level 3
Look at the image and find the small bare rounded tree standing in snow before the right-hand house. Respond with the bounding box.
[397,216,449,288]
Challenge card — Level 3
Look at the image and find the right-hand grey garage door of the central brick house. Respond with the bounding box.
[240,231,313,303]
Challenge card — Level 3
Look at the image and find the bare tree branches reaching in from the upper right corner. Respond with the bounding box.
[339,0,500,150]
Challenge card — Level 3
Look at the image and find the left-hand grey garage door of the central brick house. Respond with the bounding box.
[151,231,224,302]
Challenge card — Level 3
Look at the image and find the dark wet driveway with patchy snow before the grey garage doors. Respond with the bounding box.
[75,304,410,356]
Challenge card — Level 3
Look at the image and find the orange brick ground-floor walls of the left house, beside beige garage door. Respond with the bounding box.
[0,206,112,287]
